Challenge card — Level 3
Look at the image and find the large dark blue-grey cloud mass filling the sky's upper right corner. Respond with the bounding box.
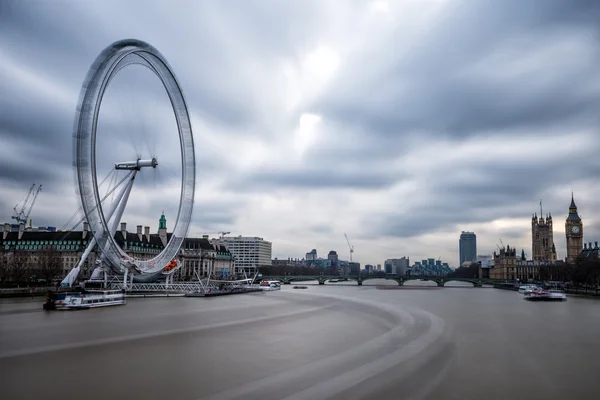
[313,1,600,137]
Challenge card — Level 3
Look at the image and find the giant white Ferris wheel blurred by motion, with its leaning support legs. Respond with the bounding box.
[63,39,196,285]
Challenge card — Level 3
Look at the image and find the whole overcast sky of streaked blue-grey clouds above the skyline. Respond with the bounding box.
[0,0,600,266]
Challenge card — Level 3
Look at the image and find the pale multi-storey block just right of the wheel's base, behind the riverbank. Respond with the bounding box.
[216,236,273,274]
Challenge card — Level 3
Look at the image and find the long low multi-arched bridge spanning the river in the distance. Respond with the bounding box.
[260,275,505,287]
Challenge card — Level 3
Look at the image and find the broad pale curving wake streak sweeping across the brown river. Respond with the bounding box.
[203,293,454,400]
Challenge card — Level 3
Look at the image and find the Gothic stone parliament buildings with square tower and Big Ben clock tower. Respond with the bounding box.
[489,195,598,281]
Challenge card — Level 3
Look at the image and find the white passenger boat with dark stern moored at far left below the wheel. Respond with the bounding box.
[44,290,127,310]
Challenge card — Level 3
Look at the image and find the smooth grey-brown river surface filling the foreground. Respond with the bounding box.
[0,284,600,400]
